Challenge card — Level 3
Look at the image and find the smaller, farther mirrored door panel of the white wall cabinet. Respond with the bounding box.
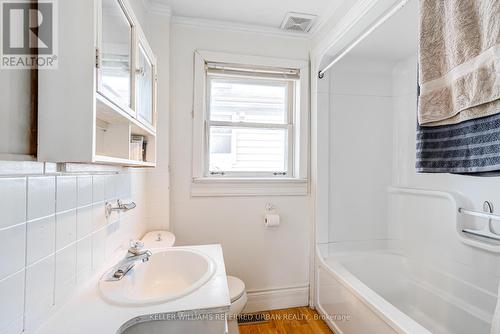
[135,42,155,126]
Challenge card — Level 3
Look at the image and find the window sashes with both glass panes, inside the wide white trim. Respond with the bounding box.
[206,68,298,177]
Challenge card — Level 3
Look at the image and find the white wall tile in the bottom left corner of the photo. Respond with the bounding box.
[0,270,24,334]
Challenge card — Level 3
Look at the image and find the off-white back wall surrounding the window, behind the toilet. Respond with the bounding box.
[170,23,310,307]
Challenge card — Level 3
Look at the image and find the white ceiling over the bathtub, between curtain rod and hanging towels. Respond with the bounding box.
[349,0,418,61]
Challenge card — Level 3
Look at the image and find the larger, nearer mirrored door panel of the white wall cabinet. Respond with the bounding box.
[98,0,133,112]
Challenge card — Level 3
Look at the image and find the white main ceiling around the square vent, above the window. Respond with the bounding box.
[154,0,345,30]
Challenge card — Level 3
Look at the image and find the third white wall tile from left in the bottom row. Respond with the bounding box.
[55,243,77,305]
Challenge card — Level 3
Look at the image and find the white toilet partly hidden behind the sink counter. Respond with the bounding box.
[141,231,248,334]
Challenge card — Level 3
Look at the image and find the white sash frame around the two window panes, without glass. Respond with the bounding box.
[204,74,300,178]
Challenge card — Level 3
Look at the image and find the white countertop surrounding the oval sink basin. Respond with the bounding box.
[32,245,231,334]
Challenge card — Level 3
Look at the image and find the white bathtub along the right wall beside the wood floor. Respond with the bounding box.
[315,245,496,334]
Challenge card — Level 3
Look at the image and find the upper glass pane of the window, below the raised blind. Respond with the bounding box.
[209,77,288,124]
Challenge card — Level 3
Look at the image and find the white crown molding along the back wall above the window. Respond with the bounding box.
[172,16,311,39]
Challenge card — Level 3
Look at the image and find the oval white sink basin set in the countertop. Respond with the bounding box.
[99,248,215,306]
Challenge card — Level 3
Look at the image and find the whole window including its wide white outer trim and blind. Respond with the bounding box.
[193,51,308,196]
